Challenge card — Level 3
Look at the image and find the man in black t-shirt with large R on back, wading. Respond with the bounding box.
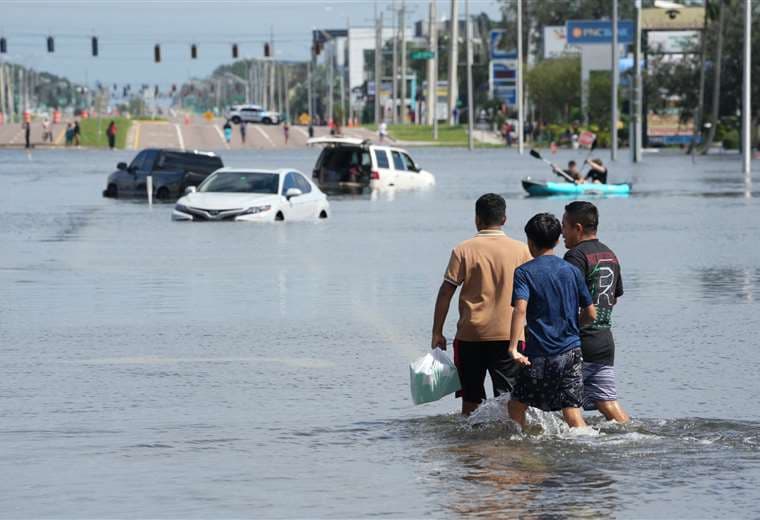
[562,201,629,423]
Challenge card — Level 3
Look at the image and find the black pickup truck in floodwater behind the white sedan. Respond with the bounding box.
[103,148,224,200]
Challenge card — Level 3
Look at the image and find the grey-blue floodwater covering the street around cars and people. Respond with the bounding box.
[0,145,760,518]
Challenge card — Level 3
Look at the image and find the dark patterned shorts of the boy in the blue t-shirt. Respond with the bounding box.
[512,348,583,412]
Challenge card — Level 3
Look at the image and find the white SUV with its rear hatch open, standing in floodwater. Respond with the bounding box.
[308,136,435,193]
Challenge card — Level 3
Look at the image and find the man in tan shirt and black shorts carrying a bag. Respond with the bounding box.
[431,193,533,415]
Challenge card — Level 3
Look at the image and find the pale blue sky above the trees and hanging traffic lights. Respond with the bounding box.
[0,0,500,89]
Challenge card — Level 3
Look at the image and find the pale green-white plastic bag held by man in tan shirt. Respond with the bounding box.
[409,348,462,404]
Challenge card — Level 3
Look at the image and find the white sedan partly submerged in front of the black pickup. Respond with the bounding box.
[172,168,330,222]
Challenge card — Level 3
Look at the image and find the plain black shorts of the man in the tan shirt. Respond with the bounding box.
[454,339,519,403]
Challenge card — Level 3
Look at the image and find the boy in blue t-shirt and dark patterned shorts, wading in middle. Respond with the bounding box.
[509,213,596,428]
